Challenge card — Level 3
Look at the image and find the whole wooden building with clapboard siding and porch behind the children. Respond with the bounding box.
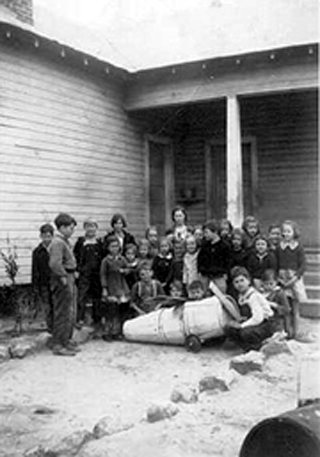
[0,0,319,282]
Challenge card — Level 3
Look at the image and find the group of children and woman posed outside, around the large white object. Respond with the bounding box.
[32,207,306,355]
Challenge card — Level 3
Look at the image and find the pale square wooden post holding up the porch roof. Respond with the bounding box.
[227,96,243,227]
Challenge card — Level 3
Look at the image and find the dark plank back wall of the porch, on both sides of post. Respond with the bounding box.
[155,91,319,245]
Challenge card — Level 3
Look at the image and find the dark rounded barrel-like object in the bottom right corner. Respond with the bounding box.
[240,401,320,457]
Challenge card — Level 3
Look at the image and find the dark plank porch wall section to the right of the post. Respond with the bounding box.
[241,91,319,245]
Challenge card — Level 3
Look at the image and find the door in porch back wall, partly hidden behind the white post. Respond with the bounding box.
[206,138,257,219]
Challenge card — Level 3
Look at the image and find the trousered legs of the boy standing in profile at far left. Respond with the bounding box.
[51,277,74,346]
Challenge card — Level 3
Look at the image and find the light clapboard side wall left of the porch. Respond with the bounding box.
[0,45,146,284]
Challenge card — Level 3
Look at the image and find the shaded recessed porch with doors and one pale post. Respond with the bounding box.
[131,90,319,246]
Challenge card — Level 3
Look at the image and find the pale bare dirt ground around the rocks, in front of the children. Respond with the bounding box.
[0,321,319,457]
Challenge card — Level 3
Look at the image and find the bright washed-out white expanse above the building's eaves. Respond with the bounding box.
[34,0,319,72]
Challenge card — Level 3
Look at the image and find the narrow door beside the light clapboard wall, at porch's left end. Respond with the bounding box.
[146,137,173,235]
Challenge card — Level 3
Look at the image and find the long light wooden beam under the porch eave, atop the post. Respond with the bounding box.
[125,62,318,111]
